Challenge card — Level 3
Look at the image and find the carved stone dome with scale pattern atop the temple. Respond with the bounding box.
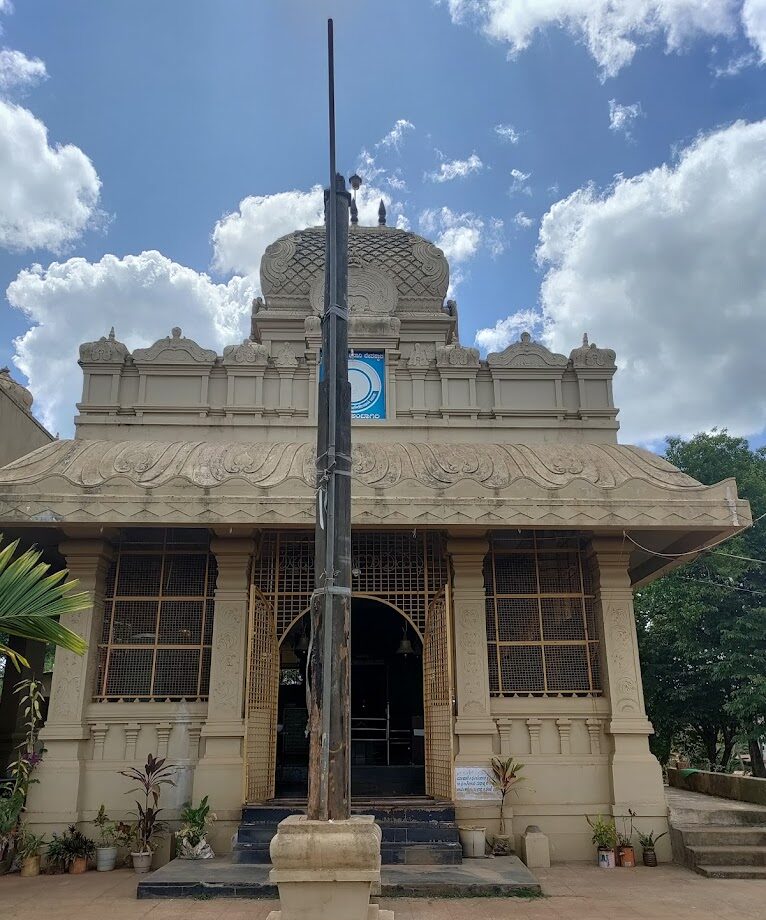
[261,225,449,314]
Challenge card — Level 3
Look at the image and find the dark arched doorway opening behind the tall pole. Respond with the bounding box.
[275,596,425,798]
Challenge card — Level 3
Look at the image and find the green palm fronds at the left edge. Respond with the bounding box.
[0,534,90,671]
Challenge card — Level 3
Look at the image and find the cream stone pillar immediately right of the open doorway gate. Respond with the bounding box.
[447,537,497,766]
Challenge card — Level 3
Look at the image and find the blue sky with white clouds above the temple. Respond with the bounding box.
[0,0,766,444]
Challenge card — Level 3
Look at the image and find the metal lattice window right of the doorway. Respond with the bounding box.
[484,531,601,696]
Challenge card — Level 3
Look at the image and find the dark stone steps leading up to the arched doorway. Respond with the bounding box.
[231,798,463,866]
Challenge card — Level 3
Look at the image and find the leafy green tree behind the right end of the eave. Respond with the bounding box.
[636,431,766,776]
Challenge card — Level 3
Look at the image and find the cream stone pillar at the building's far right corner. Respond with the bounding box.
[588,536,667,817]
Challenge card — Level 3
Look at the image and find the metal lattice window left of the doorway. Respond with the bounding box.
[96,528,217,702]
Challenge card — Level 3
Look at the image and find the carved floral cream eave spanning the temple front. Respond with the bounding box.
[0,440,750,530]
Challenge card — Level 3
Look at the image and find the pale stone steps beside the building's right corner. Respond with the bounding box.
[667,789,766,880]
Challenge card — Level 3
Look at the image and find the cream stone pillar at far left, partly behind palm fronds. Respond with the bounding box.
[27,540,112,825]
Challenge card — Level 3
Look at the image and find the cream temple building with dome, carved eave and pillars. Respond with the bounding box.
[0,226,750,860]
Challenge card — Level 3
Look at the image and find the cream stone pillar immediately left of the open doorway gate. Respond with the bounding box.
[193,537,253,836]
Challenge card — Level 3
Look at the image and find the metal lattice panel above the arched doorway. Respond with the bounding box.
[253,530,447,640]
